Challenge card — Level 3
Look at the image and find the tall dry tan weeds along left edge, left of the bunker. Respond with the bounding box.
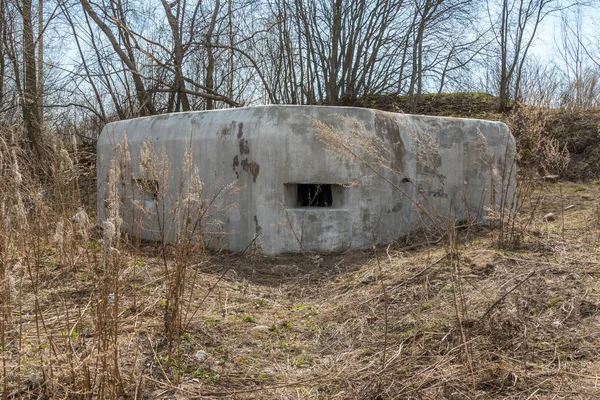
[0,127,109,398]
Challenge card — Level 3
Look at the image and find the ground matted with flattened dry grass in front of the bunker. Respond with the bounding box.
[0,183,600,400]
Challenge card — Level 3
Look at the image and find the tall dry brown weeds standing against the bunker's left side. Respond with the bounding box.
[107,133,243,372]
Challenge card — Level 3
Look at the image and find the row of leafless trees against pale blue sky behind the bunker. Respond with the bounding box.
[0,0,597,148]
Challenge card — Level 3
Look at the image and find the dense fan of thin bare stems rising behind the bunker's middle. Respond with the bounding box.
[266,0,404,105]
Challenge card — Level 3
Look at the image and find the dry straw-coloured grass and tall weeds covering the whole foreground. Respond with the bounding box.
[0,108,600,399]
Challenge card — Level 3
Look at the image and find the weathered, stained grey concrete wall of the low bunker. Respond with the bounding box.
[98,106,515,254]
